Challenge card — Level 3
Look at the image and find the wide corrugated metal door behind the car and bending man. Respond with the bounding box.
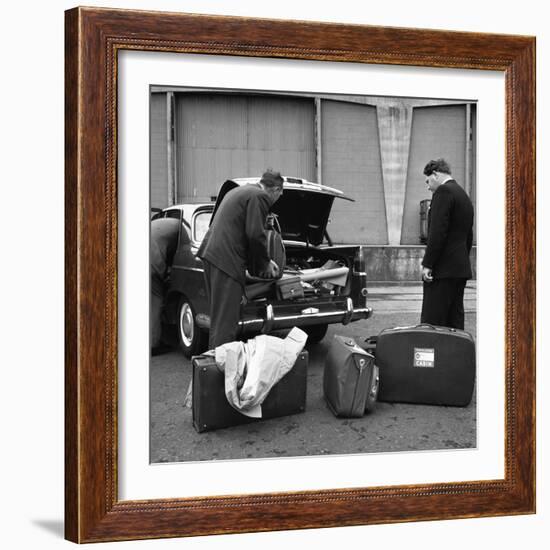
[176,94,315,202]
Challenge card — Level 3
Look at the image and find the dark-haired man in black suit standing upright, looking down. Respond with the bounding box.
[420,159,474,330]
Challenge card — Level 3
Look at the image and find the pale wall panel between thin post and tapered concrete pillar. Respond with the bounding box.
[321,100,388,244]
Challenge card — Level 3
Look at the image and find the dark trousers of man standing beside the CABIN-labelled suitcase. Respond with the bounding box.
[420,278,466,330]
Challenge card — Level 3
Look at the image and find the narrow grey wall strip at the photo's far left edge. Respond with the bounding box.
[150,93,168,208]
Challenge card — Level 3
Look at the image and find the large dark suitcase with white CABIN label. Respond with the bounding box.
[376,325,476,407]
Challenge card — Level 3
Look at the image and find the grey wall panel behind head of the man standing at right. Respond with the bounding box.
[401,105,466,244]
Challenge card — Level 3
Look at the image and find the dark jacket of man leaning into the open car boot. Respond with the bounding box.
[201,185,270,286]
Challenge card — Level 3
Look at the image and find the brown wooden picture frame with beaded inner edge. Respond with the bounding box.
[65,8,535,542]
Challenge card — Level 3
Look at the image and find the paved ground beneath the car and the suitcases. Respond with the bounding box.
[151,283,476,462]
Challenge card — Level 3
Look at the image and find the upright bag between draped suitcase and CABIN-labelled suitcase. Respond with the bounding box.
[323,335,378,418]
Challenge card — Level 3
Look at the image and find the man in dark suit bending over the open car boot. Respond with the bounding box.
[197,170,283,349]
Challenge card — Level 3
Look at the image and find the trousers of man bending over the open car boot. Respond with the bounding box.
[203,260,243,349]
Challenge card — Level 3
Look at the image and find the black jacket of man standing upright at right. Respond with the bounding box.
[422,180,474,279]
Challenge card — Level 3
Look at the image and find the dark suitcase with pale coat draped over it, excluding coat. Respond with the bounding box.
[192,351,308,433]
